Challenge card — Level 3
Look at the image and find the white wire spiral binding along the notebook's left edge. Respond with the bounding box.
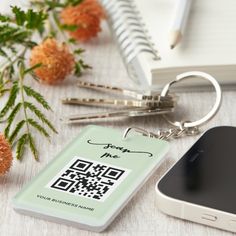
[100,0,160,80]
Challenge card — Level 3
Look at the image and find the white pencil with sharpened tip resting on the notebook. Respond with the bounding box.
[170,0,192,49]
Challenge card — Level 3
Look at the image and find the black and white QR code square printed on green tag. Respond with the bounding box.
[46,157,130,201]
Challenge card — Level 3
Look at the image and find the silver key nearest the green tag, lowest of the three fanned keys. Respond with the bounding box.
[61,108,174,124]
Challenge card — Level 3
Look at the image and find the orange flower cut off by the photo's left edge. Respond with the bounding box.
[0,134,12,175]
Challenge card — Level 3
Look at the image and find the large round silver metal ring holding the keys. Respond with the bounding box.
[161,71,222,128]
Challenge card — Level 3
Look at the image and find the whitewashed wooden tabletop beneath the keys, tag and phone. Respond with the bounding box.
[0,17,236,236]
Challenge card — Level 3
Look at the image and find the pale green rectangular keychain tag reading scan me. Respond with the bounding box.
[13,126,169,231]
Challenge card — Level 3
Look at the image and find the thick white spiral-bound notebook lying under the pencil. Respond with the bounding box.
[101,0,236,88]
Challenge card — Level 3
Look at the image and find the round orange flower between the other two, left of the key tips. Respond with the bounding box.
[30,38,75,84]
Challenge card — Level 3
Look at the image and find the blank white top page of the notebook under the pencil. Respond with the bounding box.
[135,0,236,70]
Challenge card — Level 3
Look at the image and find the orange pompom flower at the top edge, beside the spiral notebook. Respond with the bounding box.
[60,0,105,41]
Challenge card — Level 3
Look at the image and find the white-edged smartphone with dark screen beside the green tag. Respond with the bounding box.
[156,126,236,232]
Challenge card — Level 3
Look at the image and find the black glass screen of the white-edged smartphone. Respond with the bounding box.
[158,127,236,214]
